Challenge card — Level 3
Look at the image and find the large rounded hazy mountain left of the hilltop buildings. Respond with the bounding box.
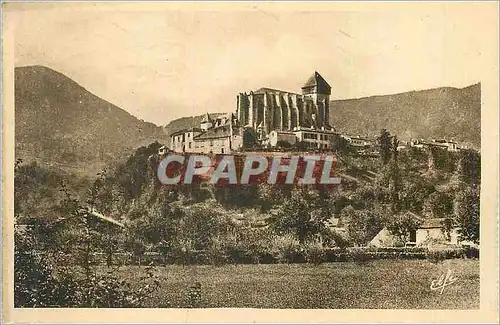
[15,66,168,175]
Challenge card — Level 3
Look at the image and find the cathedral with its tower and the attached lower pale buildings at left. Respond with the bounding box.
[170,72,338,153]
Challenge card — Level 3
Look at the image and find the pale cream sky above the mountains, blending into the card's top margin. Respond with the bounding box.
[7,3,496,125]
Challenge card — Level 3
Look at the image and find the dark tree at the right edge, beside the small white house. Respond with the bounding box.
[454,185,480,243]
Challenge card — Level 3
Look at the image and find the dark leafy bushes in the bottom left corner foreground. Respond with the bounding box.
[14,248,159,308]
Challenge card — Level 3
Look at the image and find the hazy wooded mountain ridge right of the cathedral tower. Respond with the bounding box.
[330,84,481,147]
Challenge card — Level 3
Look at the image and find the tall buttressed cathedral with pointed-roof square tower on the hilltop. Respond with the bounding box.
[236,72,333,137]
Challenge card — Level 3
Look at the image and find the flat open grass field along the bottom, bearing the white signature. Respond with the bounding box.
[101,259,479,309]
